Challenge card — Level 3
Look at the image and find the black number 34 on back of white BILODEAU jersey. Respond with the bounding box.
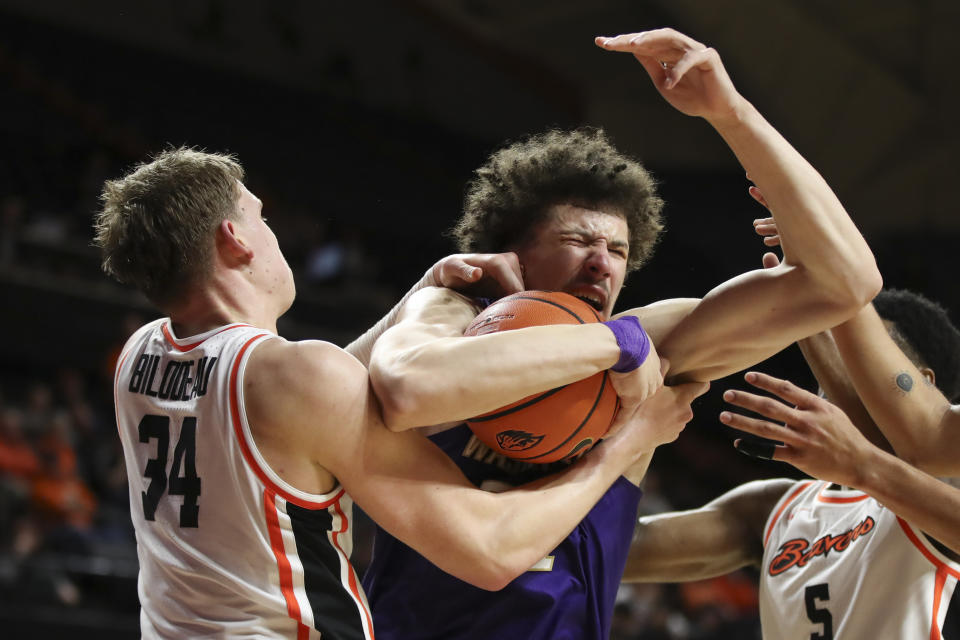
[138,415,200,527]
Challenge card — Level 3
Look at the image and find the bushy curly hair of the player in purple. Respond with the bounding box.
[451,128,663,270]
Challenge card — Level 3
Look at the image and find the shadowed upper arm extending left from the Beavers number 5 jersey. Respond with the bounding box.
[623,479,793,582]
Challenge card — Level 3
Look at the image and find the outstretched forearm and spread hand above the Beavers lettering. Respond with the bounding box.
[720,372,960,553]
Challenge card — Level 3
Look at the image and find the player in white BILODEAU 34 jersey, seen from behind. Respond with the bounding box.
[96,149,705,640]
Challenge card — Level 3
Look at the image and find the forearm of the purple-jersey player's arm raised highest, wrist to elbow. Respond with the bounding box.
[711,100,881,304]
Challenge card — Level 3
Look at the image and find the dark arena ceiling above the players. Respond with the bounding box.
[0,0,960,232]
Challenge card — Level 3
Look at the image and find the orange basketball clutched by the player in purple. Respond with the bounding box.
[463,291,620,463]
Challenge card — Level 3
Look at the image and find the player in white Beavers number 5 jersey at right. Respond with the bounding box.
[624,284,960,640]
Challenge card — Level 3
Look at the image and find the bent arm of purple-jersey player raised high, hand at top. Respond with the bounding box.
[597,29,881,380]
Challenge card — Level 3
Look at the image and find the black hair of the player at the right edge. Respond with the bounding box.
[873,289,960,402]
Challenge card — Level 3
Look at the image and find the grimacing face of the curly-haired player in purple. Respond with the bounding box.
[517,204,630,319]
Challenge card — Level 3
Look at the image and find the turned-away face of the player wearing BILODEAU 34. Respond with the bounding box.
[237,183,296,313]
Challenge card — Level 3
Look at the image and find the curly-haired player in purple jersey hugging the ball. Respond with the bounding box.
[364,29,881,640]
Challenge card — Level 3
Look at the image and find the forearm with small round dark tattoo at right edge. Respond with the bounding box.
[832,305,960,475]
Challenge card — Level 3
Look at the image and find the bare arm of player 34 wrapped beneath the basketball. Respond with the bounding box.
[247,343,705,589]
